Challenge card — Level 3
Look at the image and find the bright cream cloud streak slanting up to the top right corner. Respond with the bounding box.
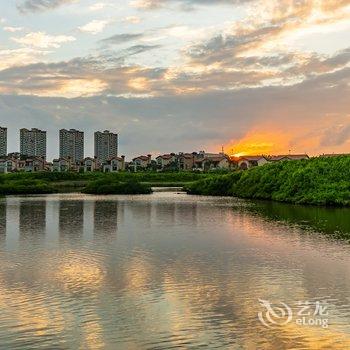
[187,0,350,66]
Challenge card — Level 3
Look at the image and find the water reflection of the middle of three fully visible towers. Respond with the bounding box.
[58,200,84,239]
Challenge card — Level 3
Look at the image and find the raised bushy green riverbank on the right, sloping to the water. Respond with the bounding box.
[186,156,350,206]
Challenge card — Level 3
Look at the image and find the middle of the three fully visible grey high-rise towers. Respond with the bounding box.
[60,129,84,163]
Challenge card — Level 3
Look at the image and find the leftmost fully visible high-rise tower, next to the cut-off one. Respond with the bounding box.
[20,129,46,158]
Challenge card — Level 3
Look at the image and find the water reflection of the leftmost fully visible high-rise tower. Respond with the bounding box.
[19,201,46,237]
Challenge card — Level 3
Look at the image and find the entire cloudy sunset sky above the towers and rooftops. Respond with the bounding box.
[0,0,350,158]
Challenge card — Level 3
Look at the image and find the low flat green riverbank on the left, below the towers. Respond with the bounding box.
[0,172,212,195]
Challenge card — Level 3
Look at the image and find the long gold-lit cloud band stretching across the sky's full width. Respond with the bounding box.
[0,45,350,98]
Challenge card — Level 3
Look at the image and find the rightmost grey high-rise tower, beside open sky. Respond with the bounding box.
[95,130,118,163]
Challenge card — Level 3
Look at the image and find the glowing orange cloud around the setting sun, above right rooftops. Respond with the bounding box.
[225,114,350,156]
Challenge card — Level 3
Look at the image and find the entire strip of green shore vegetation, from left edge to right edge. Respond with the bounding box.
[0,156,350,206]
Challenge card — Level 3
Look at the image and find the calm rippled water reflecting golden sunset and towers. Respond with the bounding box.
[0,192,350,350]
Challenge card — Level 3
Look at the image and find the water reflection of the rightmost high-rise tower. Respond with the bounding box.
[94,201,119,235]
